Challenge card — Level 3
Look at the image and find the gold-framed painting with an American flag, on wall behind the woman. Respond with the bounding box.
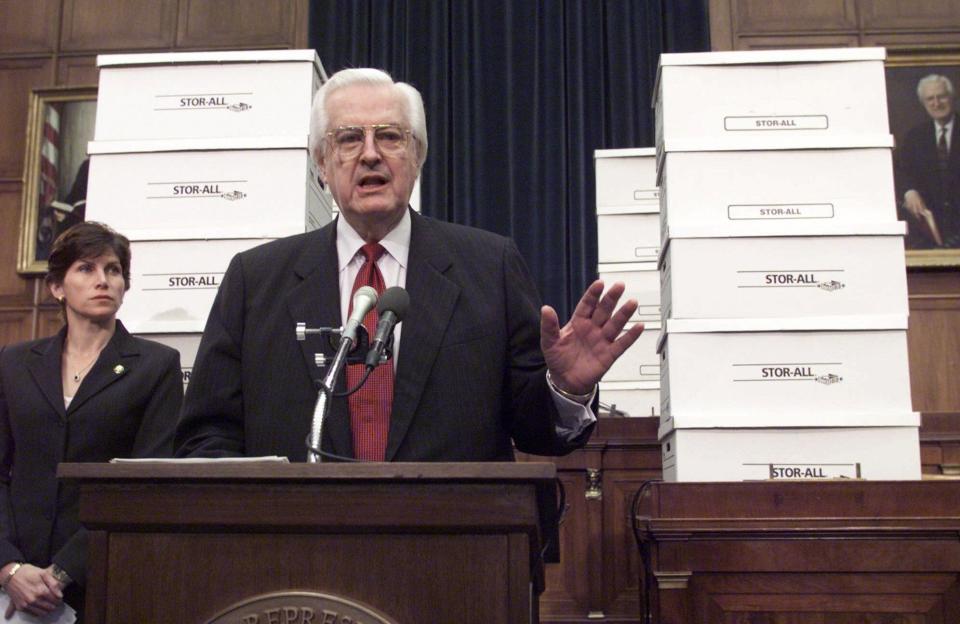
[17,87,97,273]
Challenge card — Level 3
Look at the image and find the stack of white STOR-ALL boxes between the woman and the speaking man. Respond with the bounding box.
[87,50,332,383]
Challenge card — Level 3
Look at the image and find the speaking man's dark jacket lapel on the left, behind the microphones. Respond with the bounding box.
[285,221,353,456]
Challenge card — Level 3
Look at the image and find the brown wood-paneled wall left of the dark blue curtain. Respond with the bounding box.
[0,0,308,345]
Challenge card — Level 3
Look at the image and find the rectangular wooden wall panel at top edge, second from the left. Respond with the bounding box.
[60,0,177,52]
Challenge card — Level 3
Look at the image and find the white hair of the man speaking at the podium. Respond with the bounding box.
[310,67,427,169]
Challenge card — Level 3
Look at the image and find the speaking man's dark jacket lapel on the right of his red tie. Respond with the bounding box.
[386,214,460,461]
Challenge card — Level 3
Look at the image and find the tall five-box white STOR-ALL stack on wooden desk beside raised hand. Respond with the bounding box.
[655,49,920,481]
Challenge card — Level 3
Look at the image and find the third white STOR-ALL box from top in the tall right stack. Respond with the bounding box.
[661,229,908,319]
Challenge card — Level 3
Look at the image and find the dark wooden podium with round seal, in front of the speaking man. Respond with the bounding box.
[59,462,557,624]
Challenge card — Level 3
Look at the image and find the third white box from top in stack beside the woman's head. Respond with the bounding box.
[118,239,267,334]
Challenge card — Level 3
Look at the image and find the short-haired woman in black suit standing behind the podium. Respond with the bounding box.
[0,222,183,617]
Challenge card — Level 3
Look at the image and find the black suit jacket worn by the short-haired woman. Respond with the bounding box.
[0,322,183,588]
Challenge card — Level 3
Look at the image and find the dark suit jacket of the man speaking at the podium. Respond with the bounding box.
[176,213,589,461]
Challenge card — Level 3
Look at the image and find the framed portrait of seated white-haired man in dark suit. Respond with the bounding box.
[886,47,960,267]
